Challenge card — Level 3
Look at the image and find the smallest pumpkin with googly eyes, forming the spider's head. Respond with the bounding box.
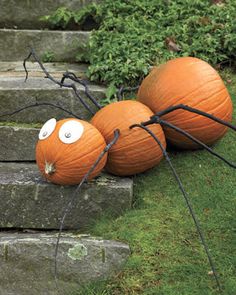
[36,118,107,185]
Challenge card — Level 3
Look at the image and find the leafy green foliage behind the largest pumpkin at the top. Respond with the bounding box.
[45,0,236,86]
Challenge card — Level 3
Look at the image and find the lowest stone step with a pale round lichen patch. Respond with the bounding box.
[0,233,130,295]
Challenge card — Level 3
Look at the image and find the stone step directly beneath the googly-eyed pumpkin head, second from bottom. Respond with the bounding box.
[0,163,133,230]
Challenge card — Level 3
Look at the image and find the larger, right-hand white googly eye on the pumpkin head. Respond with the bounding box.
[59,120,84,143]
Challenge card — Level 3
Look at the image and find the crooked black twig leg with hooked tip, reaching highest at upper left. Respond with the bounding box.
[23,48,95,115]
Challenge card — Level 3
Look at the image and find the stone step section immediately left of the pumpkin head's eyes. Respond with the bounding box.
[0,126,39,161]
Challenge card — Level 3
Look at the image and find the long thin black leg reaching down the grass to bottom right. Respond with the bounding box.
[130,124,222,292]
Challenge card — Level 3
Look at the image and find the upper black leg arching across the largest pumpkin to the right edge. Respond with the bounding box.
[146,104,236,131]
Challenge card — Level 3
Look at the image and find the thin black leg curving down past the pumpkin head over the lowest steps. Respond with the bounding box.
[54,129,120,287]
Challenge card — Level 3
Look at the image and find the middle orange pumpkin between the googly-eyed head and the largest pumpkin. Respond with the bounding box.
[91,100,166,176]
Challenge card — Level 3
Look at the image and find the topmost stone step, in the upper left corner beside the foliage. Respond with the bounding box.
[0,0,97,29]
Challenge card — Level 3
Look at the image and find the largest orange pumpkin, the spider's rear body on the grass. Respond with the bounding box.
[138,57,233,149]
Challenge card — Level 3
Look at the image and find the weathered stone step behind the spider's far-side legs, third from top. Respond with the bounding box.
[0,62,106,123]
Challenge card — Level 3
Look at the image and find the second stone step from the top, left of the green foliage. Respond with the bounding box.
[0,28,90,62]
